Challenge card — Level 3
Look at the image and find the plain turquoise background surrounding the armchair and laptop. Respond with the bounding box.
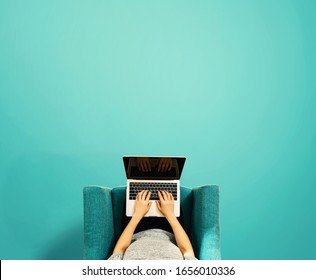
[0,0,316,259]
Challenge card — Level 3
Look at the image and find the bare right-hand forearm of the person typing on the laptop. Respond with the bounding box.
[166,215,194,257]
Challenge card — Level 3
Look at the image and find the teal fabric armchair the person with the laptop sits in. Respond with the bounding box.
[83,185,221,260]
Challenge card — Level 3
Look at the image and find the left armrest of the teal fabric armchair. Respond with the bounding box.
[83,186,115,260]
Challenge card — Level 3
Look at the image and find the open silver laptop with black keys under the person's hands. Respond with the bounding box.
[123,156,186,217]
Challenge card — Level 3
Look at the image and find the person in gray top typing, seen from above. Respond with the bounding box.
[109,190,196,260]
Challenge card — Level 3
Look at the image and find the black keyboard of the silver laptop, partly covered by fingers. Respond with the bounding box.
[129,182,177,200]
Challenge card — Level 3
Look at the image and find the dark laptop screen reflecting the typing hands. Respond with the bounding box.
[123,156,185,180]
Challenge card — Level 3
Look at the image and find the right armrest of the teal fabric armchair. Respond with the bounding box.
[191,185,221,260]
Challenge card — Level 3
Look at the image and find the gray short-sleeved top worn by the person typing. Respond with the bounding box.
[109,229,196,260]
